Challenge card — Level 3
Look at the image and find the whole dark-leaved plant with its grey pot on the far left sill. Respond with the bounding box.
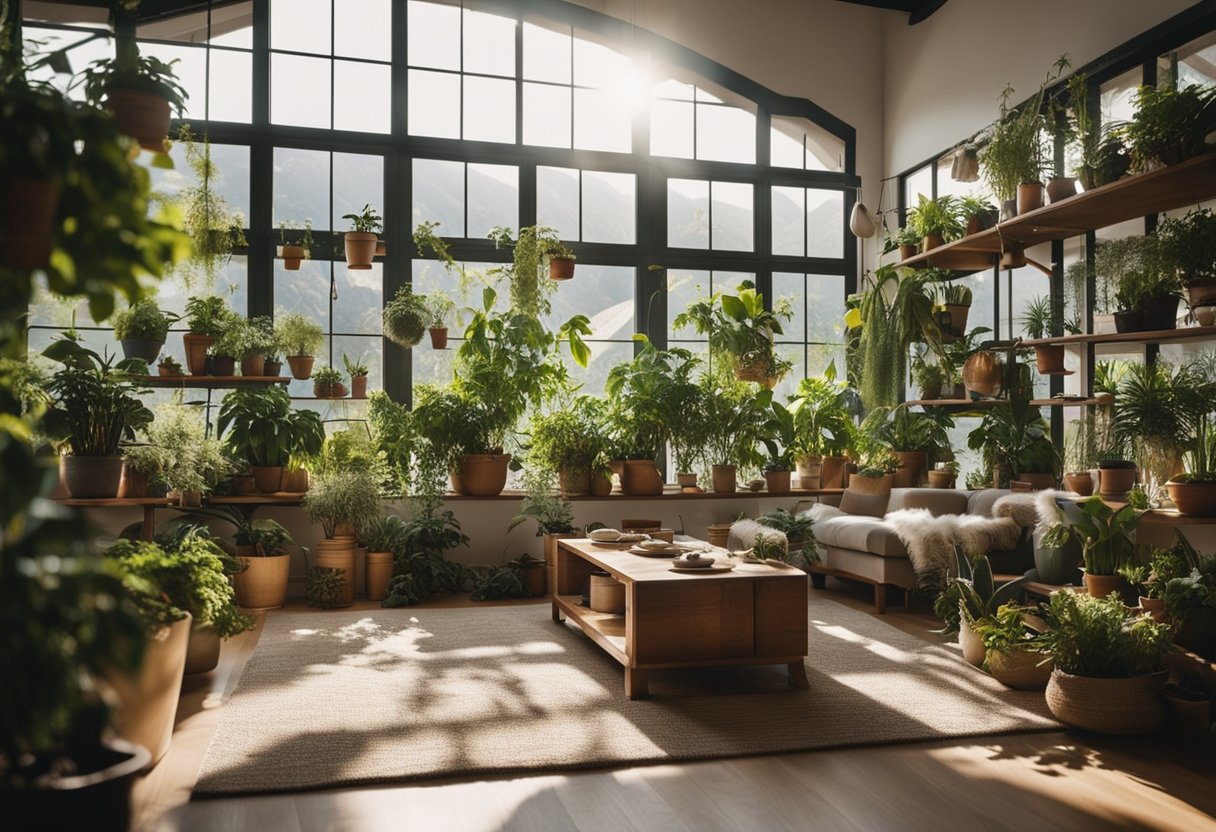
[43,337,152,499]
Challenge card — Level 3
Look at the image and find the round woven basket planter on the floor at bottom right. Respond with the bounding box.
[1047,669,1167,733]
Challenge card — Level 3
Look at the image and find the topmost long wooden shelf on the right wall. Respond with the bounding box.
[896,153,1216,272]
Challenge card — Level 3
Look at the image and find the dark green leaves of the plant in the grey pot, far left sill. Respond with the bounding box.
[43,337,152,456]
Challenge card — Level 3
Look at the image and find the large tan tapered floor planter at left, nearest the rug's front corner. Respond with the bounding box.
[107,615,191,765]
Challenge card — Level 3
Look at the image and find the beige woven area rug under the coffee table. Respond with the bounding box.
[195,594,1059,796]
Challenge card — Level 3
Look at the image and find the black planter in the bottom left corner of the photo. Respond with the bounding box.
[0,740,152,832]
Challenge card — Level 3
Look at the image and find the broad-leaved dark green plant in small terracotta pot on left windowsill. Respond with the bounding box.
[218,386,325,494]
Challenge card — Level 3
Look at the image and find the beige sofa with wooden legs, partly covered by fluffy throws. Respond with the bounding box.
[811,488,1035,613]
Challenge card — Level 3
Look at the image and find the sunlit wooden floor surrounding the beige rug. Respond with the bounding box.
[135,580,1216,832]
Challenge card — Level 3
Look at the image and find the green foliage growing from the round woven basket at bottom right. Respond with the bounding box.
[1043,592,1172,679]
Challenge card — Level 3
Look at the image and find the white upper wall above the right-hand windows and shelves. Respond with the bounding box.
[883,0,1193,175]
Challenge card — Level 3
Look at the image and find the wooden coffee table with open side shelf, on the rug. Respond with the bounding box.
[553,538,807,699]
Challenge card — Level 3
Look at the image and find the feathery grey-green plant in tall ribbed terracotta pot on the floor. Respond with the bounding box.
[303,470,381,607]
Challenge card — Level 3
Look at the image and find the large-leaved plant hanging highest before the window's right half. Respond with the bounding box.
[674,281,793,388]
